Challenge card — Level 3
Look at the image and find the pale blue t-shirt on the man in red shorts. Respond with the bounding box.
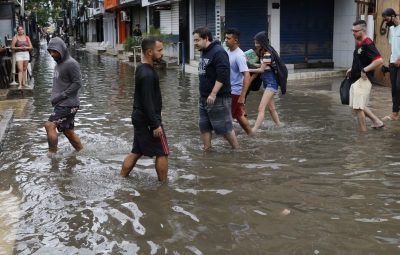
[228,48,249,95]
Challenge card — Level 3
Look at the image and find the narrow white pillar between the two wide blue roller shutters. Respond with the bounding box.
[268,0,281,53]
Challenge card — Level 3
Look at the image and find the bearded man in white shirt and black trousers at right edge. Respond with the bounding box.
[382,8,400,120]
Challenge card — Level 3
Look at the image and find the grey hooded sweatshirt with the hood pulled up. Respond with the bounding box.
[47,37,82,107]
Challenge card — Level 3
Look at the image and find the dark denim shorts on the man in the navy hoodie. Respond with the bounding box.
[199,96,233,135]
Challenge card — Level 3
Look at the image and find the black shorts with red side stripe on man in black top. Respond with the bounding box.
[131,126,169,157]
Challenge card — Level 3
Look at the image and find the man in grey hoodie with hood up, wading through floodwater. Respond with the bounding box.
[45,37,83,155]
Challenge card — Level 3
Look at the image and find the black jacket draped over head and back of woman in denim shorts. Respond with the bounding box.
[254,31,288,94]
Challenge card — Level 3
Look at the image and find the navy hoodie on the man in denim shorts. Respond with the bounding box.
[199,41,231,97]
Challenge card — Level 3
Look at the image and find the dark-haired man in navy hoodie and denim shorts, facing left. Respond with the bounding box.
[193,27,239,150]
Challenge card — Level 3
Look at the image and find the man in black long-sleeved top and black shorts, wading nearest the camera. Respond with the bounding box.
[120,38,169,182]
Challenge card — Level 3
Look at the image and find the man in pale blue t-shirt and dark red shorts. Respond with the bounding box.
[225,28,252,135]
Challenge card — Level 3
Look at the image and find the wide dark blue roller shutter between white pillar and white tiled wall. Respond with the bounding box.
[280,0,334,64]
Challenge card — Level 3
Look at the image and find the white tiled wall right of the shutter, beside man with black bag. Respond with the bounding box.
[333,0,357,68]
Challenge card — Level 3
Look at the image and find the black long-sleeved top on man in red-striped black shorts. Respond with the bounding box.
[132,64,162,129]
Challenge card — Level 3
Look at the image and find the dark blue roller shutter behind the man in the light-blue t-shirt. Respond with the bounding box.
[225,0,268,51]
